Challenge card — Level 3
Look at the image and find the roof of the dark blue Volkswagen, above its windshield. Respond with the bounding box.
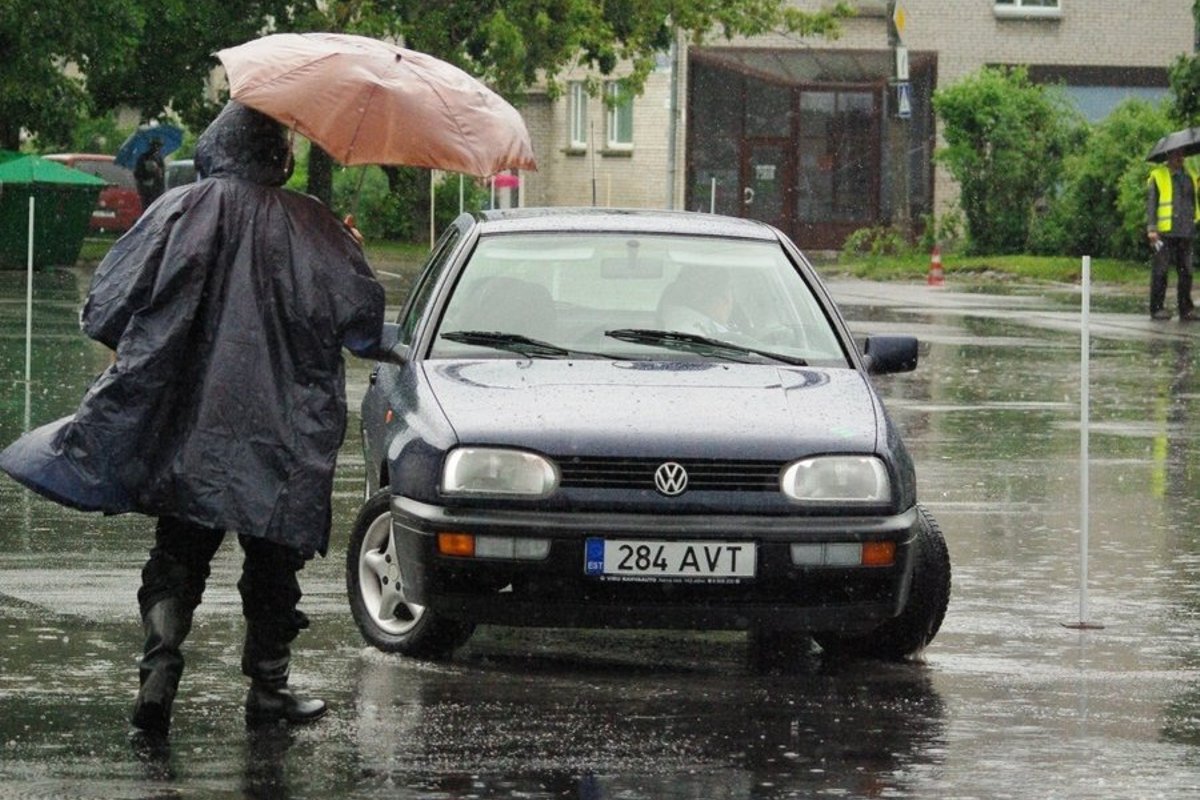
[475,206,778,241]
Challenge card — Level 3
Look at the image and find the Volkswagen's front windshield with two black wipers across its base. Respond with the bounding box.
[430,231,848,367]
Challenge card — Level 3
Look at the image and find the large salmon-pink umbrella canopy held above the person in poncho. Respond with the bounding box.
[217,34,538,178]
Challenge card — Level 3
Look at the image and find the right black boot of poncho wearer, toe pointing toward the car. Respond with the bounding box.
[241,620,326,726]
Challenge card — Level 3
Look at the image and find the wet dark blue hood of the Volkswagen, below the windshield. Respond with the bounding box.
[425,359,882,459]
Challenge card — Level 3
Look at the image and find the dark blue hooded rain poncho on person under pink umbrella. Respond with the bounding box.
[0,102,384,555]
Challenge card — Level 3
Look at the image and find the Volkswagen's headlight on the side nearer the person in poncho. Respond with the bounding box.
[442,447,558,498]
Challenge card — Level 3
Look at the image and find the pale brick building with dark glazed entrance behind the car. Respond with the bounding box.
[522,0,1195,248]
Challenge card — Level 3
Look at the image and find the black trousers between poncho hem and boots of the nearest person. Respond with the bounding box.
[138,517,308,644]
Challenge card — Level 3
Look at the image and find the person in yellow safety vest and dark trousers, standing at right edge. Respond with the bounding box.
[1146,150,1200,320]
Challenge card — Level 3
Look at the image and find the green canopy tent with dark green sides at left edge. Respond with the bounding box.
[0,151,106,270]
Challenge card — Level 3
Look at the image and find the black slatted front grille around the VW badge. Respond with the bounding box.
[554,456,784,492]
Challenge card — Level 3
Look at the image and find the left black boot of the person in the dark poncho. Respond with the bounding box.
[130,597,192,735]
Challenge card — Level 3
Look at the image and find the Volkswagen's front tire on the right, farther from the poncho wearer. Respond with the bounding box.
[812,504,950,661]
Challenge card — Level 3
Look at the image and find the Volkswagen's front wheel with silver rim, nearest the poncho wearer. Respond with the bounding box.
[346,488,475,658]
